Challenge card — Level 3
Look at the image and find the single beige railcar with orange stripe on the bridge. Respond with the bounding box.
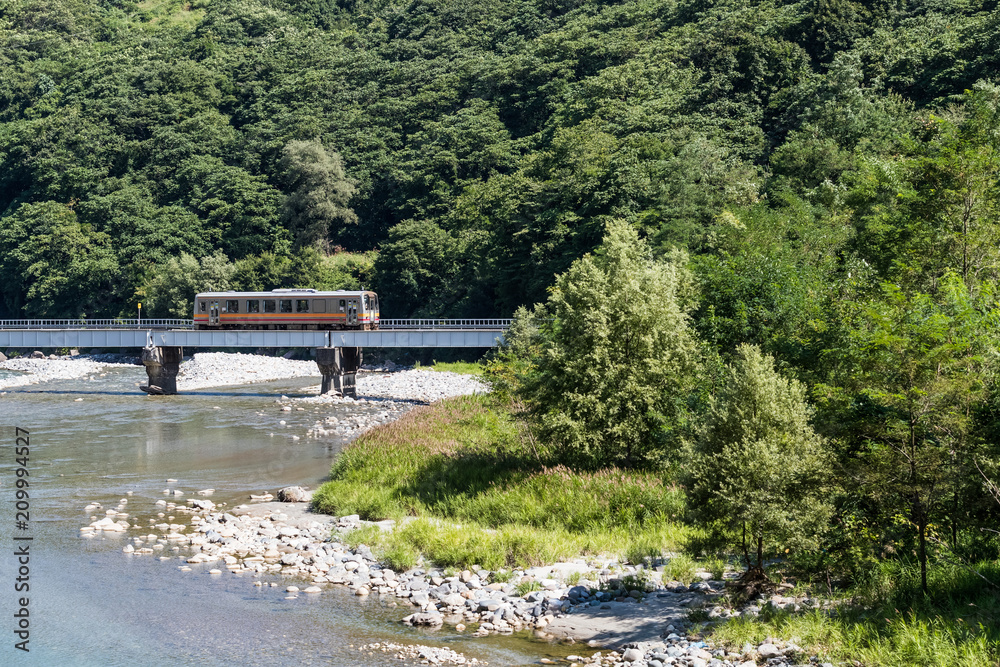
[194,289,379,330]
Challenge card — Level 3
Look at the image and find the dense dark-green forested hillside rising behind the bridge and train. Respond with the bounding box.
[0,0,1000,320]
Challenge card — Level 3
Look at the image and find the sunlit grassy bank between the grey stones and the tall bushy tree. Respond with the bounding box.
[314,396,689,569]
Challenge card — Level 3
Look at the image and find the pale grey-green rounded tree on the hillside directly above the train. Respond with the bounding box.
[280,140,358,250]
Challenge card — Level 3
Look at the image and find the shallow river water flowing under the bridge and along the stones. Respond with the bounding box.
[0,367,566,666]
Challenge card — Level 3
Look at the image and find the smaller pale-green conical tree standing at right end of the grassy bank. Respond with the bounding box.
[689,345,833,582]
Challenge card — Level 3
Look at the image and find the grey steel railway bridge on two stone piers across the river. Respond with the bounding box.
[0,319,510,396]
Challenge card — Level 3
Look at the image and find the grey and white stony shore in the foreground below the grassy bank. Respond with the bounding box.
[81,494,836,667]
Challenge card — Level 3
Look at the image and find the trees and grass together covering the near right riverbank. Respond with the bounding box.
[315,224,1000,665]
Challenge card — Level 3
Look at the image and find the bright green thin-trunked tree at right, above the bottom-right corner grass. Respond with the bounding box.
[817,273,997,592]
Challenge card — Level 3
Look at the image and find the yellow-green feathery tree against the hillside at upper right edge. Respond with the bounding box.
[848,84,1000,292]
